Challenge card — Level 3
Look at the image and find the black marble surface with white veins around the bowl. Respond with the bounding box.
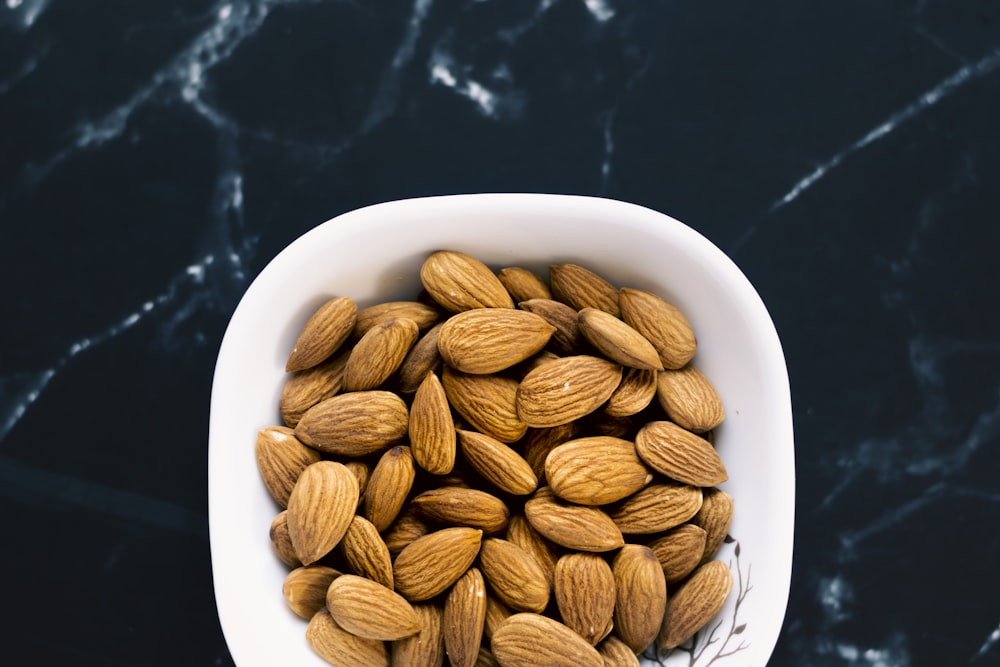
[0,0,1000,667]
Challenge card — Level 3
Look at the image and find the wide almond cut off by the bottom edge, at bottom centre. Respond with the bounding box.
[491,612,604,667]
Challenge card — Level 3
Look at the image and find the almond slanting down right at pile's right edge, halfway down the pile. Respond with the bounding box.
[635,421,729,486]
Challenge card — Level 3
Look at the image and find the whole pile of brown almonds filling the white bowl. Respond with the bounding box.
[256,251,733,667]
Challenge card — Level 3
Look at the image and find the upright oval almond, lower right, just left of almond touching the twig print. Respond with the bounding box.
[611,544,667,653]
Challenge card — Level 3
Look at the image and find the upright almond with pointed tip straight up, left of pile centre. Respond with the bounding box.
[409,371,457,475]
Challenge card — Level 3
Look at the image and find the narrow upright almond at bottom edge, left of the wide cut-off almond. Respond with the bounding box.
[442,567,486,667]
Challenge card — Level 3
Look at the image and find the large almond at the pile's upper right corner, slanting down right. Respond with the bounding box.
[618,287,698,368]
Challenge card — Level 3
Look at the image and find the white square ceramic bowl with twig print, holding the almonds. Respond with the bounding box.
[208,194,795,667]
